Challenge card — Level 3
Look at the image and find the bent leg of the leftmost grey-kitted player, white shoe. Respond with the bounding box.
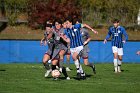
[43,54,51,77]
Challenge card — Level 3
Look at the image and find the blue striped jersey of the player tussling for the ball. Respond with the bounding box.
[64,25,83,48]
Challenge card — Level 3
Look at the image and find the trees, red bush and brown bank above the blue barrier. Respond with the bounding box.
[0,0,140,40]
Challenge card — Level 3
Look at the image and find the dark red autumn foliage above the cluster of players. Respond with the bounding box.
[28,0,82,28]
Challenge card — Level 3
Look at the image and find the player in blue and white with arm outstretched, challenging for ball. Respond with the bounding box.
[65,19,97,79]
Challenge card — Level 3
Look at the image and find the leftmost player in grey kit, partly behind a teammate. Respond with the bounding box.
[40,24,54,77]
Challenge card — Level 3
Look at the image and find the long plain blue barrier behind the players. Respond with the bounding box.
[0,40,140,63]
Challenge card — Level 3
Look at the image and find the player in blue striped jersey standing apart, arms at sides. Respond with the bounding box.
[104,19,128,73]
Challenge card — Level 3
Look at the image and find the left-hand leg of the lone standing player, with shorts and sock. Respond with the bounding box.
[112,46,118,73]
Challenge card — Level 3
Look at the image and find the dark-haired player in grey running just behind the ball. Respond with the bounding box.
[52,20,70,80]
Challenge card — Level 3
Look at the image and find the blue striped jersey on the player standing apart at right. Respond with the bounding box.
[106,26,128,48]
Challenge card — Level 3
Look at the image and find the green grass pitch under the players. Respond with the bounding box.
[0,63,140,93]
